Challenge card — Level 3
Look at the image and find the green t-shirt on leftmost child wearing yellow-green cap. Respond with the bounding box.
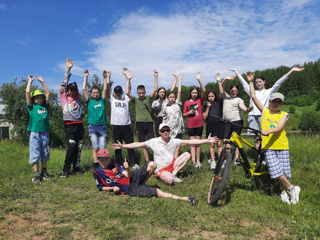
[26,102,50,132]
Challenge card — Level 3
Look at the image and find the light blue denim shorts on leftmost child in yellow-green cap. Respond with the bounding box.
[29,132,50,164]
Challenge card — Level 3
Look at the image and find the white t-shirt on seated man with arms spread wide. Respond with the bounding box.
[145,137,182,173]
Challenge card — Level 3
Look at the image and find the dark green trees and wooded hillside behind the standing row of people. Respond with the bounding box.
[0,59,320,146]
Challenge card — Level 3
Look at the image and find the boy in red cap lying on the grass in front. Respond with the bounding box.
[93,149,197,205]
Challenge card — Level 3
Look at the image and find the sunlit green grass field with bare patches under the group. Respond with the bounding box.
[0,134,320,239]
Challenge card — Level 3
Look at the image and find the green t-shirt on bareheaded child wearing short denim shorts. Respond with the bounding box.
[87,97,108,125]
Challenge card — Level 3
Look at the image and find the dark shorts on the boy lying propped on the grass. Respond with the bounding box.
[127,162,158,197]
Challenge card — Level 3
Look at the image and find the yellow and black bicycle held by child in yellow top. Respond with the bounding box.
[207,117,278,205]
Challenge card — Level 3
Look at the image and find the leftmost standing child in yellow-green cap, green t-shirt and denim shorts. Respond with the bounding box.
[26,75,50,183]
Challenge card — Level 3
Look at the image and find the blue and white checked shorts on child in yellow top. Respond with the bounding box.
[264,150,291,179]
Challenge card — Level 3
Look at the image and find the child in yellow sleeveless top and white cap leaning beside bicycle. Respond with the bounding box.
[246,72,300,204]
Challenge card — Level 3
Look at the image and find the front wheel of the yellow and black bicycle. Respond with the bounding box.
[207,149,232,205]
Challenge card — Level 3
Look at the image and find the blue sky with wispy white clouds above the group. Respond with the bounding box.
[0,0,320,93]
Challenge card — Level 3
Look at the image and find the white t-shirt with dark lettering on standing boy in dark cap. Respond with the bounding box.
[109,95,131,126]
